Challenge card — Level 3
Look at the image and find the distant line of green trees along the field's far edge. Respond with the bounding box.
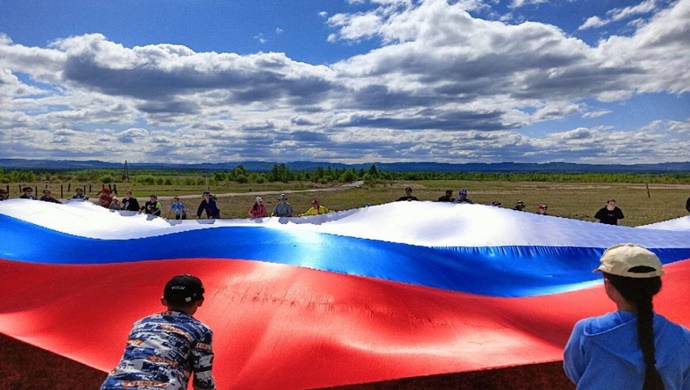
[0,164,690,186]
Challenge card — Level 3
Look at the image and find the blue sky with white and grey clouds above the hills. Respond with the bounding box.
[0,0,690,164]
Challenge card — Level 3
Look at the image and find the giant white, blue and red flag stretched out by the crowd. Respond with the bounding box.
[0,199,690,389]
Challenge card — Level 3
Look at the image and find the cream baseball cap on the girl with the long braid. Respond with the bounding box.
[594,244,664,279]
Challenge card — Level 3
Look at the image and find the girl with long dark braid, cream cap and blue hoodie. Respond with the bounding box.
[563,244,690,389]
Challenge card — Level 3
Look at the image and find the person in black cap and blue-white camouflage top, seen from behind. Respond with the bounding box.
[100,275,216,390]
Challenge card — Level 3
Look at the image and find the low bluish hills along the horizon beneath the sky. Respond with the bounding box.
[0,159,690,173]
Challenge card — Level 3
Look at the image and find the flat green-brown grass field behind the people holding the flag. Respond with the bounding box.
[10,180,690,226]
